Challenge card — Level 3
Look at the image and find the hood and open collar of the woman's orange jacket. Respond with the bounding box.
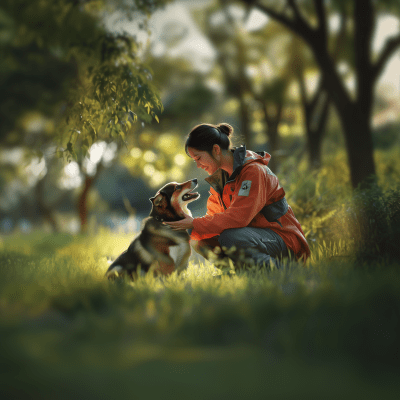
[205,146,271,194]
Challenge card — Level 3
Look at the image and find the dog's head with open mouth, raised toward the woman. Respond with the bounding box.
[150,179,200,221]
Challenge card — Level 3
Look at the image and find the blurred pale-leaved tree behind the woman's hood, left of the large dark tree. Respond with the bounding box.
[207,4,304,170]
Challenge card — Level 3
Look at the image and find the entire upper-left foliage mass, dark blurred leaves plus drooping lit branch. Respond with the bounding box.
[0,0,165,159]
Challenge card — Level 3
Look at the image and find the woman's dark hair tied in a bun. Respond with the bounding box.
[185,123,233,155]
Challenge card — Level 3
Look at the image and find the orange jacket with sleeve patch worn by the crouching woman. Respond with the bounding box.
[191,146,310,260]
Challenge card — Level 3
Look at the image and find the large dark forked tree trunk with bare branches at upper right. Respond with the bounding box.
[242,0,400,187]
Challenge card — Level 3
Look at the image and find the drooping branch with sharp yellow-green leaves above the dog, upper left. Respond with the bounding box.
[65,33,163,161]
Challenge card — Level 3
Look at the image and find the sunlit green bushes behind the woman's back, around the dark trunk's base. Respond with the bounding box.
[278,142,400,265]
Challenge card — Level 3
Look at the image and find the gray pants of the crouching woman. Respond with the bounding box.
[192,226,290,266]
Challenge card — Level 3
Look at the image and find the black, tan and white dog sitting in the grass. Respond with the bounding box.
[106,179,200,280]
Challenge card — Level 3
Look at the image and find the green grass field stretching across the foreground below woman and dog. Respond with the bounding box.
[0,231,400,399]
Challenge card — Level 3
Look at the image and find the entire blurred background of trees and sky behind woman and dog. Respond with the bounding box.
[0,0,400,239]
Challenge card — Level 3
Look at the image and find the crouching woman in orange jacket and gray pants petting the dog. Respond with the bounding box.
[167,123,310,265]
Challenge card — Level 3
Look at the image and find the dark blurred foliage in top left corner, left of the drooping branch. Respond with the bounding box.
[0,0,98,145]
